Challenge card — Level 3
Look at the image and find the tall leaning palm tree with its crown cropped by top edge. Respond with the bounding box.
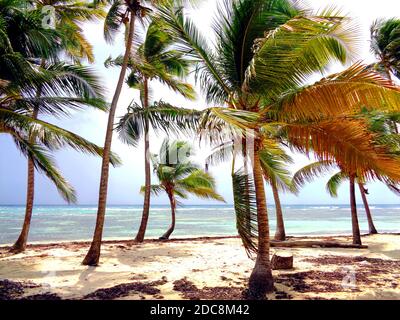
[82,0,198,266]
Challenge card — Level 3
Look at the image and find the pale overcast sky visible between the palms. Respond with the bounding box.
[0,0,400,205]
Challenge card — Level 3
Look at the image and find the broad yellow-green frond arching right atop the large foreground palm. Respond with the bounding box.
[245,13,357,101]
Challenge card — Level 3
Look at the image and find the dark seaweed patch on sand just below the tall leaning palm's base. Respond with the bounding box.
[82,278,167,300]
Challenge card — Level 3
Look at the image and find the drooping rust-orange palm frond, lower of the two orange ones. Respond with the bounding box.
[287,118,400,181]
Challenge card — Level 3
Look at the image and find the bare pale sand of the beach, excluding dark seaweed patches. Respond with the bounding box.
[0,235,400,299]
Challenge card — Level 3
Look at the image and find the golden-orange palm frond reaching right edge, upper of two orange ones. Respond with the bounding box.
[272,63,400,121]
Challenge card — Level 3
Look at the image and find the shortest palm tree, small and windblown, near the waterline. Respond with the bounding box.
[142,140,225,240]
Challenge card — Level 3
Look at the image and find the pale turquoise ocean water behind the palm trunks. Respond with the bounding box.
[0,205,400,244]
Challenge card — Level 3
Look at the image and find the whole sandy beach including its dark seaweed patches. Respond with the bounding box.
[0,234,400,300]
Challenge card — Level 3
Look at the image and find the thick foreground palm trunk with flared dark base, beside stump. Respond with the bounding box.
[249,142,274,299]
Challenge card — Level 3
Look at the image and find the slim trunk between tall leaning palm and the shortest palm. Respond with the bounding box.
[135,78,151,242]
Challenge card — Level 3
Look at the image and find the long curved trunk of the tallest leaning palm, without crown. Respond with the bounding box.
[82,12,135,266]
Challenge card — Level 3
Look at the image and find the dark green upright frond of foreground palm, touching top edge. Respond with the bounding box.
[214,0,300,91]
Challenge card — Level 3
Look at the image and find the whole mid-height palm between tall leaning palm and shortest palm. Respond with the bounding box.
[106,22,195,242]
